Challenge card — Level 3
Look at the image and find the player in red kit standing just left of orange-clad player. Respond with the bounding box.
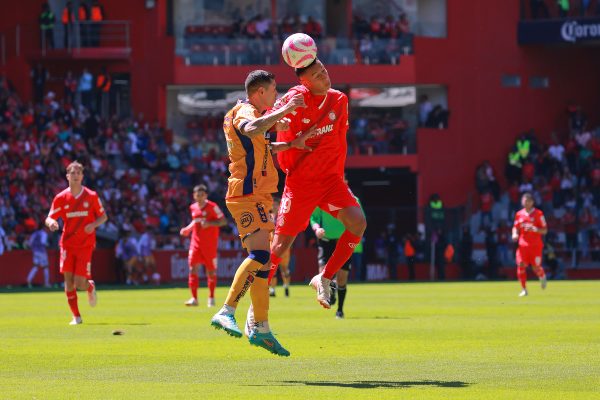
[179,185,227,307]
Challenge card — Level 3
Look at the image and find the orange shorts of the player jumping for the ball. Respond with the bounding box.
[225,193,275,241]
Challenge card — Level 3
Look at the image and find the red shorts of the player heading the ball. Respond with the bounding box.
[275,176,360,236]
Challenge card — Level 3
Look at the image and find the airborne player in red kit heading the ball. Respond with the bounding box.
[271,59,367,308]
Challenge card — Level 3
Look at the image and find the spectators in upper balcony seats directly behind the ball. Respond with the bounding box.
[185,13,413,64]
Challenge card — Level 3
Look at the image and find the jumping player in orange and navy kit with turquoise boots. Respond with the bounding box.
[211,70,313,356]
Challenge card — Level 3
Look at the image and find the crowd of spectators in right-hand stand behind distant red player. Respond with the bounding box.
[475,106,600,267]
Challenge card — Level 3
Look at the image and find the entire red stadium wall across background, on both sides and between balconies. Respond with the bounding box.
[0,0,600,206]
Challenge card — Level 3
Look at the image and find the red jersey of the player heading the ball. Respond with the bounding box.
[275,85,348,181]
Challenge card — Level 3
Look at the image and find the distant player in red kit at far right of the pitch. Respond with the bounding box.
[512,193,548,297]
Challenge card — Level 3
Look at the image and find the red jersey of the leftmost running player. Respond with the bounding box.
[48,186,104,248]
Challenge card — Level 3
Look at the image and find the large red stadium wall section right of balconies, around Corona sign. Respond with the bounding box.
[415,0,600,206]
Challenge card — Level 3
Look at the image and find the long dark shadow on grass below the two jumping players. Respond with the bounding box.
[249,380,470,389]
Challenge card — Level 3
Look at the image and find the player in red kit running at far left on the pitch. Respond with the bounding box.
[46,161,108,325]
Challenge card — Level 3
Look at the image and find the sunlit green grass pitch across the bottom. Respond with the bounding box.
[0,281,600,400]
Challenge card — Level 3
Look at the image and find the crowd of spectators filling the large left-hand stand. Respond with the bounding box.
[0,74,237,253]
